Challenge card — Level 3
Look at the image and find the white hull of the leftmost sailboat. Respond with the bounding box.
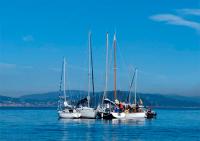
[58,111,81,119]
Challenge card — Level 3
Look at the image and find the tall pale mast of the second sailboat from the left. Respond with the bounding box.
[87,32,91,107]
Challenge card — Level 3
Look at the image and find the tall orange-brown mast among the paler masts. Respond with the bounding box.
[113,33,117,99]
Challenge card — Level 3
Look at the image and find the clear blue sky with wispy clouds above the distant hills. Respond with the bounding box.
[0,0,200,97]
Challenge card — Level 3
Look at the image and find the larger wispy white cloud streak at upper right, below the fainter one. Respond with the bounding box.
[150,14,200,30]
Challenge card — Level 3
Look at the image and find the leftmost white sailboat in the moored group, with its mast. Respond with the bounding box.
[58,58,81,119]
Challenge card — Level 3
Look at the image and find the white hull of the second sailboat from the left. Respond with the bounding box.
[77,107,97,119]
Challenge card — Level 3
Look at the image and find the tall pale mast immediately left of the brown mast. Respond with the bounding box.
[102,32,108,104]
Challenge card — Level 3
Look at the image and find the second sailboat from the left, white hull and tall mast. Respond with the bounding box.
[77,32,97,119]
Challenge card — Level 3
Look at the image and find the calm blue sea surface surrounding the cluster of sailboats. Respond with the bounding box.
[0,108,200,141]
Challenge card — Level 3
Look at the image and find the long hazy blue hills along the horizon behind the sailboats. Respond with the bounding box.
[0,90,200,107]
